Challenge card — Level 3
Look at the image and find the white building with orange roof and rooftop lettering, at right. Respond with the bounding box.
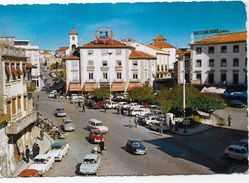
[190,32,247,85]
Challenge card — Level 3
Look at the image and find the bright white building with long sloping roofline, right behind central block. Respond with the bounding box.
[123,40,171,79]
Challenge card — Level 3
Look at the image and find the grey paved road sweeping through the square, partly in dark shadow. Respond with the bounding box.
[35,92,247,176]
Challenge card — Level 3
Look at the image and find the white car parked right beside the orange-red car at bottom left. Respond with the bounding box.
[28,154,54,175]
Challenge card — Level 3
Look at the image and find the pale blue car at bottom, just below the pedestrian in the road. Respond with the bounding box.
[79,154,100,175]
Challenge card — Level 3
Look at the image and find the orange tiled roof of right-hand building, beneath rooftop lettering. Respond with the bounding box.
[194,32,247,44]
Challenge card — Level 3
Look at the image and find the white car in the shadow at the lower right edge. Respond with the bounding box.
[224,145,248,161]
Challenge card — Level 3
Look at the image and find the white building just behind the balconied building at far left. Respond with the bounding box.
[15,40,41,91]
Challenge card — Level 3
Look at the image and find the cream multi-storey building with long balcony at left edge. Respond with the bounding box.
[0,37,36,176]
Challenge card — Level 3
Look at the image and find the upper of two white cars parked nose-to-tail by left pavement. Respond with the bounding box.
[47,141,70,161]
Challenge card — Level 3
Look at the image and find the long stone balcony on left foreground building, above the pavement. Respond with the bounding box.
[6,111,37,135]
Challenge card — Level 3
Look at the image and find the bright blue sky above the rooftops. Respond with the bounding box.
[0,1,247,51]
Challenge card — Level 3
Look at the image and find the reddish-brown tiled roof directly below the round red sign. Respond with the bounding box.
[80,39,130,48]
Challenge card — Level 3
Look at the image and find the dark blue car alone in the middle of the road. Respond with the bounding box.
[125,140,147,155]
